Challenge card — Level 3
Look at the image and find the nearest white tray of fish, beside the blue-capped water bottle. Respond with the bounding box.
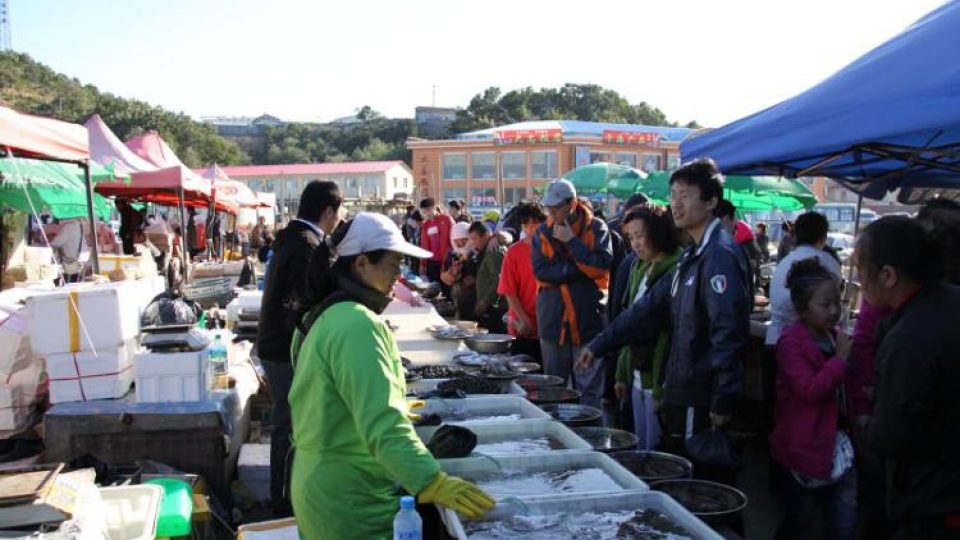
[438,491,722,540]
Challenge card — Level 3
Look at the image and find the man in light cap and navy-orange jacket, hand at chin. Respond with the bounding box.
[532,179,613,408]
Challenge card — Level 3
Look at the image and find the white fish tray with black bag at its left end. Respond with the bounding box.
[417,420,592,456]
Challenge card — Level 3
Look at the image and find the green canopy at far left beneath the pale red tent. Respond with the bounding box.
[0,158,122,219]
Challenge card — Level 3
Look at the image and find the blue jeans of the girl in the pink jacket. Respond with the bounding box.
[775,460,857,540]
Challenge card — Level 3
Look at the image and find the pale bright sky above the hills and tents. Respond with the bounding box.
[9,0,942,126]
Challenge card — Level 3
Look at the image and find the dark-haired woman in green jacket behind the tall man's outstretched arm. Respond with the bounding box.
[615,207,681,450]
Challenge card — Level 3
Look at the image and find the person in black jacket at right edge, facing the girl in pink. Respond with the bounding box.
[856,216,960,539]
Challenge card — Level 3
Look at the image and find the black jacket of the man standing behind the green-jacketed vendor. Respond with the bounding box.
[257,221,321,362]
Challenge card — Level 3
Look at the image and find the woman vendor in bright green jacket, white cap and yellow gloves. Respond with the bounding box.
[289,213,494,540]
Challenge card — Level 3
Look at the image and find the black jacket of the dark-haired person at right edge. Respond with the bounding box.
[866,285,960,520]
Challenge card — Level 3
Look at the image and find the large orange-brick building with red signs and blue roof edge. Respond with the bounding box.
[407,120,693,207]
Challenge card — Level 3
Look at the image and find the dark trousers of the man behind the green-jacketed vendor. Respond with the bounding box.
[260,358,293,518]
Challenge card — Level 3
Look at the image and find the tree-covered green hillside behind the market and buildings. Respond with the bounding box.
[0,52,699,167]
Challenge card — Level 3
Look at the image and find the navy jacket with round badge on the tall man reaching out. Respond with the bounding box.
[589,219,750,414]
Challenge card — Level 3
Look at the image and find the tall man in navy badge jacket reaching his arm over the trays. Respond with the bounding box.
[577,159,750,494]
